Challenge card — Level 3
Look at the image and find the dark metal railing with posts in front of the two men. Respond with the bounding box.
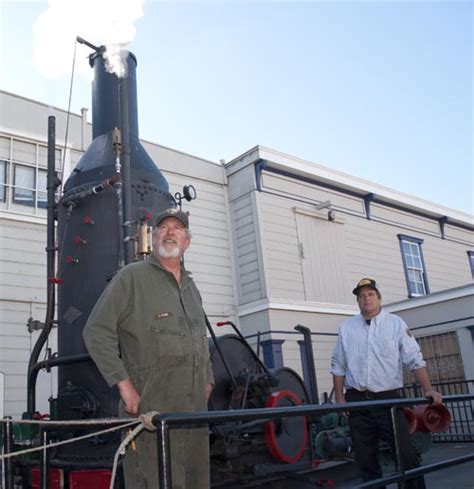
[153,395,474,489]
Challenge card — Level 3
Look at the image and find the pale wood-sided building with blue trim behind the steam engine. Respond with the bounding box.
[0,91,474,416]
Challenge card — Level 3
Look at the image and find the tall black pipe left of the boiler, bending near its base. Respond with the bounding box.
[23,116,60,418]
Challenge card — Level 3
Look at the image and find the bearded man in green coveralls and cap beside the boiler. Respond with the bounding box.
[84,208,214,489]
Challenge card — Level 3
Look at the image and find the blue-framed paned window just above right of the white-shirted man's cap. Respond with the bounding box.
[398,234,430,297]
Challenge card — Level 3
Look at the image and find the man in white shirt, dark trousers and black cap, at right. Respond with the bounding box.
[331,278,442,489]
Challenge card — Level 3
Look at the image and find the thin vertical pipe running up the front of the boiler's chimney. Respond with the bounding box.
[118,76,133,265]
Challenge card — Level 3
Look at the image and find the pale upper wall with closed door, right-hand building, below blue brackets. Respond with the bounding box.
[258,171,473,304]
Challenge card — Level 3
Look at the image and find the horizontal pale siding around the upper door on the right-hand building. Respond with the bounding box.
[262,172,473,304]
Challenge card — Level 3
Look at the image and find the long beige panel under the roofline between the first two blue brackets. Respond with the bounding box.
[262,171,365,214]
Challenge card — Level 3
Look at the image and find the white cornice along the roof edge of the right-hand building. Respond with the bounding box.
[225,145,474,227]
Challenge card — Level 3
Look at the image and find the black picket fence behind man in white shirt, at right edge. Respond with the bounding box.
[403,380,474,443]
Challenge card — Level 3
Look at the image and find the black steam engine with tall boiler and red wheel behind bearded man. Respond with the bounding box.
[3,40,442,489]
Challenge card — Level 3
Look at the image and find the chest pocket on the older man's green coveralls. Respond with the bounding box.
[150,313,186,359]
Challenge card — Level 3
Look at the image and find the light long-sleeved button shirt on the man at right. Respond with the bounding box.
[331,310,426,392]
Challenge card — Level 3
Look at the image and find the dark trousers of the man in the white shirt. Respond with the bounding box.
[345,389,426,489]
